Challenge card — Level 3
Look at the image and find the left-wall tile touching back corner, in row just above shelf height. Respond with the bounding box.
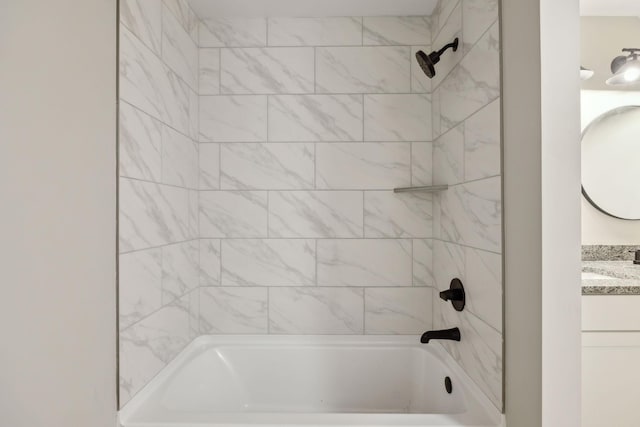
[162,126,198,189]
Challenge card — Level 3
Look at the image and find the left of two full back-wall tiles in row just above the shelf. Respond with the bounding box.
[221,143,315,190]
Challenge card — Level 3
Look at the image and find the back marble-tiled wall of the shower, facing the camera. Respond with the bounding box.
[195,17,434,344]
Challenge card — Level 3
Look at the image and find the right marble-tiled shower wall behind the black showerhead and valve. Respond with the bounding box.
[432,0,503,409]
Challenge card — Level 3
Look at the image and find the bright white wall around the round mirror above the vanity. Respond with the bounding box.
[581,90,640,245]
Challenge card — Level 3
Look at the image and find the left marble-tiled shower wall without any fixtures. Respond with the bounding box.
[119,0,200,405]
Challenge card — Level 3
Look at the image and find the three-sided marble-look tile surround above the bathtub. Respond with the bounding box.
[120,0,502,407]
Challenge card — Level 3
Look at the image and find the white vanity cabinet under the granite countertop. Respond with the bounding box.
[582,295,640,427]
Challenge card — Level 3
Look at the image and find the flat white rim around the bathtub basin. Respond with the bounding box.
[118,334,506,427]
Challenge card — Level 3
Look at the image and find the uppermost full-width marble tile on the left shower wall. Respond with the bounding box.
[119,28,192,135]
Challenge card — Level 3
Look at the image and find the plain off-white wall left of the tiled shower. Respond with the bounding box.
[0,0,116,427]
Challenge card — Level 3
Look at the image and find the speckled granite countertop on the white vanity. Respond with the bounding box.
[582,261,640,295]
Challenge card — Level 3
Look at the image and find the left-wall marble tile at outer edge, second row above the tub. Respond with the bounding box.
[118,249,162,330]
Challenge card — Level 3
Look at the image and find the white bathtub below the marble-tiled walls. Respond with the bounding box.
[120,335,501,427]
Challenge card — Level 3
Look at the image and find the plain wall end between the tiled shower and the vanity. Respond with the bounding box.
[502,0,580,427]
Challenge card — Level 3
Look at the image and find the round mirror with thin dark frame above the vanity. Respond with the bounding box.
[582,106,640,220]
